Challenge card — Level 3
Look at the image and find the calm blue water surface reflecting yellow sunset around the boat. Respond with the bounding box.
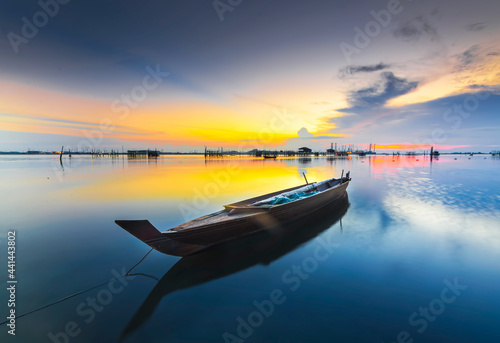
[0,156,500,343]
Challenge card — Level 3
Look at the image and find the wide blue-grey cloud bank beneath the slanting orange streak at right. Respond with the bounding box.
[329,91,500,146]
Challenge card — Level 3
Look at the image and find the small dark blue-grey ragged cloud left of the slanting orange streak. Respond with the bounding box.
[347,71,418,107]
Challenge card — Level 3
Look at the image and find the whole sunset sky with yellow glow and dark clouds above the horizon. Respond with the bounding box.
[0,0,500,152]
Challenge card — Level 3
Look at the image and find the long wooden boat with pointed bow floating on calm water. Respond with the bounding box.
[115,172,351,256]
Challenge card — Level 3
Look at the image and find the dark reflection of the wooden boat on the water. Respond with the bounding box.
[120,192,349,341]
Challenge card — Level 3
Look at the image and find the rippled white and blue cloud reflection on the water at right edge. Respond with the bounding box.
[383,177,500,264]
